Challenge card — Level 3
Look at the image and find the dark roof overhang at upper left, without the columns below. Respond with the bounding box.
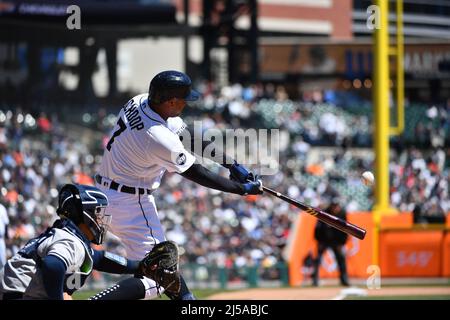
[0,0,198,45]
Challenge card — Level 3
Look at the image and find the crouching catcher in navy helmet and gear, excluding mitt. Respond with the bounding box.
[0,184,148,300]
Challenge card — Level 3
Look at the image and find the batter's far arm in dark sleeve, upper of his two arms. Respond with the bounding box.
[180,128,234,169]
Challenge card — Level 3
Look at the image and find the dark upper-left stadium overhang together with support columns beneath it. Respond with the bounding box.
[0,0,199,100]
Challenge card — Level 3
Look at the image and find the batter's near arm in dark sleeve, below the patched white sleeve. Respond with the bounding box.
[181,163,246,195]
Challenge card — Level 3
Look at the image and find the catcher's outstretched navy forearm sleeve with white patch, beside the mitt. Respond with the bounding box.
[93,250,139,274]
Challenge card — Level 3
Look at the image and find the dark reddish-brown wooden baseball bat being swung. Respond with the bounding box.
[263,186,366,240]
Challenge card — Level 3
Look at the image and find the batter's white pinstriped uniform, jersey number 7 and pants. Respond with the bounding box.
[96,94,195,299]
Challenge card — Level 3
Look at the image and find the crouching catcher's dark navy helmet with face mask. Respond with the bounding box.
[56,184,111,244]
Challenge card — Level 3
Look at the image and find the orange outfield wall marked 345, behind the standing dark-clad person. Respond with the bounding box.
[289,212,450,286]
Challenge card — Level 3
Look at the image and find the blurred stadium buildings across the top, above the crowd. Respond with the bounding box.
[0,0,450,105]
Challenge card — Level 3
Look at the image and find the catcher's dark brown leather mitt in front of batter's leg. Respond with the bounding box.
[139,241,180,294]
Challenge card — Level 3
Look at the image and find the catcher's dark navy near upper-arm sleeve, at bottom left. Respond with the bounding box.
[41,255,67,300]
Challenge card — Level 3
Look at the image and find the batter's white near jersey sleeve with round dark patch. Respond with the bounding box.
[147,126,195,173]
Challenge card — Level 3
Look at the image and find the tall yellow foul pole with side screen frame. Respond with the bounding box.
[372,0,404,265]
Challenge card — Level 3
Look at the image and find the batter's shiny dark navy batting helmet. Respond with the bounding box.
[148,70,200,103]
